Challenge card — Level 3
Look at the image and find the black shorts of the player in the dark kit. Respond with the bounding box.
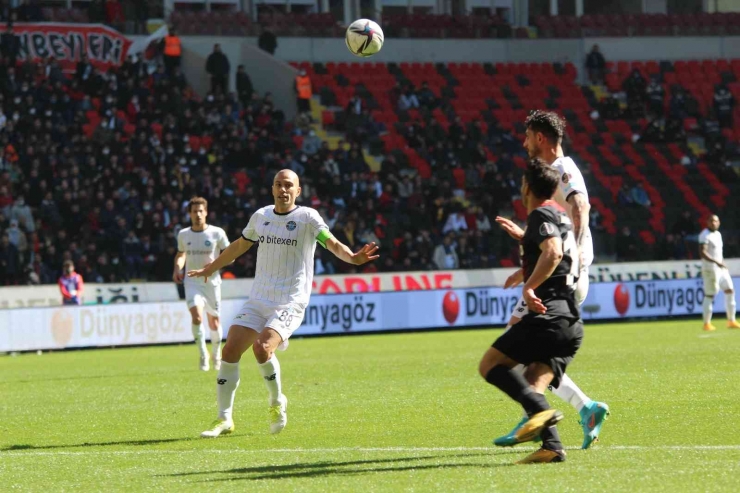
[492,314,583,388]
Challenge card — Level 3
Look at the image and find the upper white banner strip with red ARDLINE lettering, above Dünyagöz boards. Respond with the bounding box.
[0,259,740,310]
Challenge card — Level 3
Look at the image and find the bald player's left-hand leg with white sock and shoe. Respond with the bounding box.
[200,325,259,438]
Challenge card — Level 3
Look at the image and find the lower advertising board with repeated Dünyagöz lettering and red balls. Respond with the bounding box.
[0,277,740,352]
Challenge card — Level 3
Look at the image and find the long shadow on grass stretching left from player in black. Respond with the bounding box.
[169,450,521,482]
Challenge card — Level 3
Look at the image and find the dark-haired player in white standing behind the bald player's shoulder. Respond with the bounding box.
[172,197,229,371]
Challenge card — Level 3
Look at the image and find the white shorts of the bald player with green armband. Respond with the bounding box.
[231,300,307,342]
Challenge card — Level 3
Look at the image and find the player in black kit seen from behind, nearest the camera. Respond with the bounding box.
[479,159,583,464]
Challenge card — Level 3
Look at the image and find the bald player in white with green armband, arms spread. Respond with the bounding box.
[188,170,378,438]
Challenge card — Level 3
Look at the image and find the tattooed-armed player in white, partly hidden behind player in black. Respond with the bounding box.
[494,110,609,449]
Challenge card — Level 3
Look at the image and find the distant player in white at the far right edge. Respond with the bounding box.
[699,215,740,330]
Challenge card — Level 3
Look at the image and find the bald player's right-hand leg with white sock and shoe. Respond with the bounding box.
[252,327,288,434]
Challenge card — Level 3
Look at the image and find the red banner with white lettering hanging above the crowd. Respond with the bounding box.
[0,22,131,71]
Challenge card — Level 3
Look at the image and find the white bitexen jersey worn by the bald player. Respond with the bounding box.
[242,205,329,304]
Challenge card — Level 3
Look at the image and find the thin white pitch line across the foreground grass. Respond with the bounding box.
[0,445,740,457]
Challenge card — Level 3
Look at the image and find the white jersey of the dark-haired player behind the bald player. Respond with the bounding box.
[177,224,229,286]
